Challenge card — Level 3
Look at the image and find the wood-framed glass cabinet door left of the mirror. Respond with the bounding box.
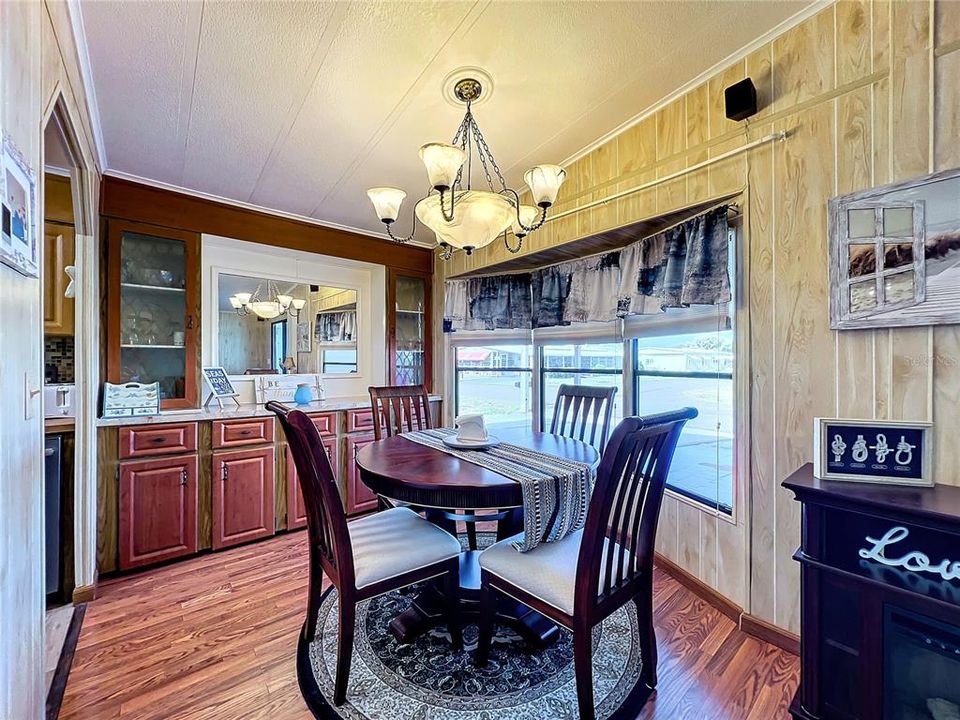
[109,222,196,408]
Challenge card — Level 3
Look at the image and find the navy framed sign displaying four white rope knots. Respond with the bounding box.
[813,418,934,487]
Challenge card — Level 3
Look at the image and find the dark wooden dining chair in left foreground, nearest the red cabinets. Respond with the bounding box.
[267,402,463,705]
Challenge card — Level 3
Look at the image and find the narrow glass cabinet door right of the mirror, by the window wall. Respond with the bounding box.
[390,274,430,385]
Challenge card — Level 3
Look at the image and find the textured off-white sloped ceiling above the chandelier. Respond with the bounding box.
[81,0,807,242]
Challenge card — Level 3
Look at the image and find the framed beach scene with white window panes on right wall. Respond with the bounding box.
[830,168,960,330]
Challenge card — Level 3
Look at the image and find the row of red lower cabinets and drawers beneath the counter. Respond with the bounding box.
[97,400,440,574]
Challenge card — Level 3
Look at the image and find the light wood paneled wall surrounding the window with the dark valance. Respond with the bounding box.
[434,0,960,631]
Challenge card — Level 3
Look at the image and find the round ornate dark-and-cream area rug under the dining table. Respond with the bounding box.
[297,544,645,720]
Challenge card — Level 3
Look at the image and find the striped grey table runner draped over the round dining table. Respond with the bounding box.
[402,428,596,552]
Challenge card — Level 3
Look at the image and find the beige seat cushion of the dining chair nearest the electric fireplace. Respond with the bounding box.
[480,530,630,615]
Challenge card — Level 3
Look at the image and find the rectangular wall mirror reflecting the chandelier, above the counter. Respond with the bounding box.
[217,273,360,375]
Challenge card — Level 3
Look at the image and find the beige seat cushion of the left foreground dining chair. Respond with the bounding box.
[347,508,460,588]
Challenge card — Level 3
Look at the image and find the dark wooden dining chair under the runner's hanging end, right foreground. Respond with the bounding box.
[476,408,697,720]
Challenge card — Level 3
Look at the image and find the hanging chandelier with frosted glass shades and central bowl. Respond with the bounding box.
[367,78,566,260]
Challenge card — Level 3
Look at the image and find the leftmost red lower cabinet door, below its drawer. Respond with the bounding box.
[119,455,197,570]
